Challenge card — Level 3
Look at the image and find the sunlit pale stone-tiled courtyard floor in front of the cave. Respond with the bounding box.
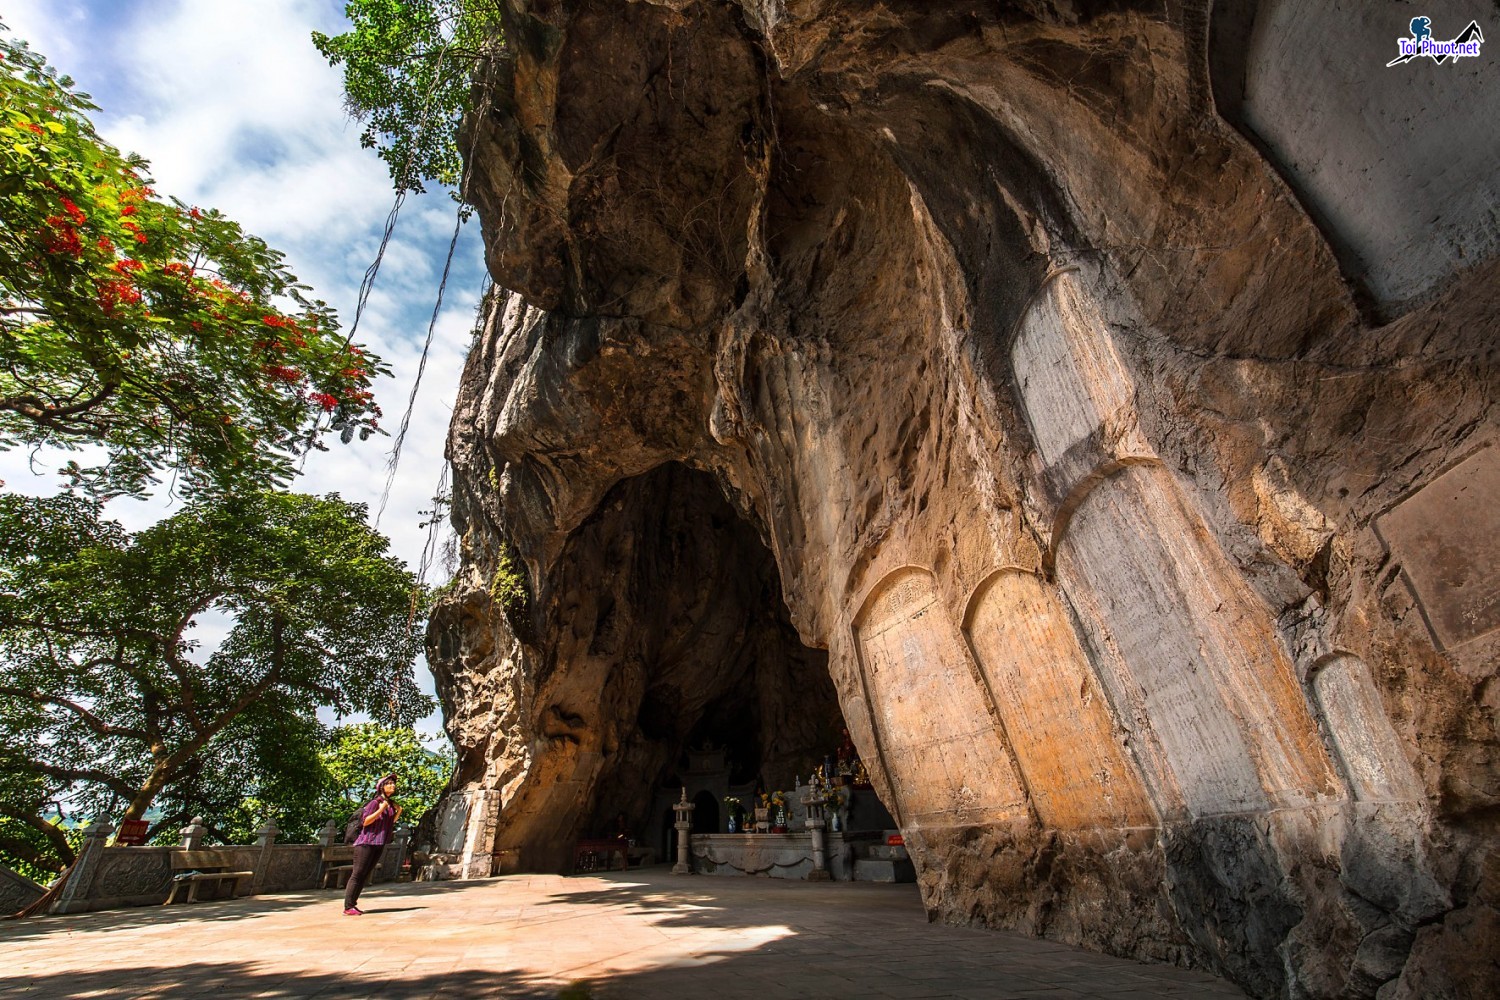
[0,867,1244,1000]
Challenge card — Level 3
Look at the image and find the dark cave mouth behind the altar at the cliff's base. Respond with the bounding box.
[573,462,870,852]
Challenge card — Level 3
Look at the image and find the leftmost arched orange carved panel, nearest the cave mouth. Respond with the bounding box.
[855,570,1026,828]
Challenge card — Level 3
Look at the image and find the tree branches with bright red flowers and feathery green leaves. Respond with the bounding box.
[0,25,386,495]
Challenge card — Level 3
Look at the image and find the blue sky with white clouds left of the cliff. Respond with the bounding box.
[0,0,483,743]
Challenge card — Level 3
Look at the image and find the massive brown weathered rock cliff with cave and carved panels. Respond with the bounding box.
[417,0,1500,999]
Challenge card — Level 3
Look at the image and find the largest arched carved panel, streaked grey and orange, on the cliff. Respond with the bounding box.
[1058,466,1331,816]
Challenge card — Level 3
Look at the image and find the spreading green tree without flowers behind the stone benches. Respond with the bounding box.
[0,492,432,861]
